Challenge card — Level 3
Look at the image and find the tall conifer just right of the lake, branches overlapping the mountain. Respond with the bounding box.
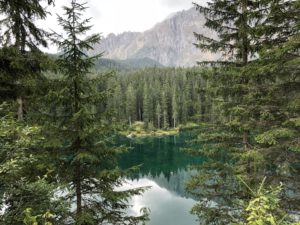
[188,0,298,224]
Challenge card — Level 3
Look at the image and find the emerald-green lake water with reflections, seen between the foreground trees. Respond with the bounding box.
[120,132,202,225]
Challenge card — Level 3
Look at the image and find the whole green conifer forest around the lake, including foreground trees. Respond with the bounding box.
[0,0,300,225]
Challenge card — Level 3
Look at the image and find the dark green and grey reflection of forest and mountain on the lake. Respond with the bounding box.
[119,133,203,197]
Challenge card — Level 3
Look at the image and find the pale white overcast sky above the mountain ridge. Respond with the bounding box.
[39,0,206,52]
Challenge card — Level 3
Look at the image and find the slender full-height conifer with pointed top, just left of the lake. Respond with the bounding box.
[49,0,149,225]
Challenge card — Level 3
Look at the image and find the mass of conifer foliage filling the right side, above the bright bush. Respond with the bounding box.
[188,0,300,224]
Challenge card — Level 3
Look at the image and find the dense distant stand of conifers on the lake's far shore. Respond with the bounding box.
[108,68,213,129]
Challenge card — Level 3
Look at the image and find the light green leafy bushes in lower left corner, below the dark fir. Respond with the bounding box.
[0,105,64,225]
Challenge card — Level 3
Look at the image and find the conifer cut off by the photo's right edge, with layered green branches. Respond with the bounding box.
[248,1,300,212]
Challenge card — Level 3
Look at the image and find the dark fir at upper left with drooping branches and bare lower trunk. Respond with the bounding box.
[0,0,53,120]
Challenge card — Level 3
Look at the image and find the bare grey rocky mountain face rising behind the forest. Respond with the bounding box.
[94,8,219,67]
